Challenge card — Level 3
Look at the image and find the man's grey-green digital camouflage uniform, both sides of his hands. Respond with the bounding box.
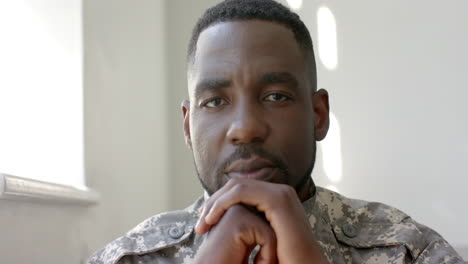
[89,187,466,264]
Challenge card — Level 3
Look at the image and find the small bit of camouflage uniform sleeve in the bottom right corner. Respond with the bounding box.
[414,239,468,264]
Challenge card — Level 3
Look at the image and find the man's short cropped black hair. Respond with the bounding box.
[187,0,316,90]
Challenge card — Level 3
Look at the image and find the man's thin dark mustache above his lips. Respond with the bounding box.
[217,145,288,175]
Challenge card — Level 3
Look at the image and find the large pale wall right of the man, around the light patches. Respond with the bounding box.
[290,0,468,257]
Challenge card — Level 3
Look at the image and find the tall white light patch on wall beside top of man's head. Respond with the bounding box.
[317,6,338,70]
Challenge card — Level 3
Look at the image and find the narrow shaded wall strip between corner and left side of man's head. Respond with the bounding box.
[166,0,220,209]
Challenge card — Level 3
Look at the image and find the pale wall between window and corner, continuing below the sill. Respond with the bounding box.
[0,0,169,264]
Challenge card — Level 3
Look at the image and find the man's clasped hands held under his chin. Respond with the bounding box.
[194,178,328,264]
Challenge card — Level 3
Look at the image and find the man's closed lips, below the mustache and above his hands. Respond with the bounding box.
[225,157,278,180]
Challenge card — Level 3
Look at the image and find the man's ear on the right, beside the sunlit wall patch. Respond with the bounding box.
[312,89,330,141]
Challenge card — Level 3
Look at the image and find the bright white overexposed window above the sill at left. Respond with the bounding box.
[0,0,84,186]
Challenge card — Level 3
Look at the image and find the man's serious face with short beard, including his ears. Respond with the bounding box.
[183,20,328,194]
